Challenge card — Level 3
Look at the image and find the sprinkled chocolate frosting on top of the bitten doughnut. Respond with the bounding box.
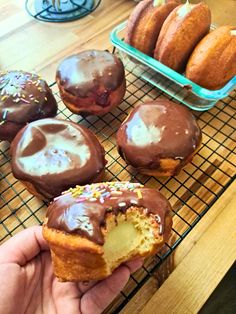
[47,182,171,245]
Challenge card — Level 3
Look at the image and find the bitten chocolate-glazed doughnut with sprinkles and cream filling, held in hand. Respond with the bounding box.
[43,182,172,281]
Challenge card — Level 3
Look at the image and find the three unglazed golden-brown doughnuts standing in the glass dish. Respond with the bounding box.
[125,0,236,90]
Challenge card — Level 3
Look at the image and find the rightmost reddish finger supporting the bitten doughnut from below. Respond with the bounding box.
[80,260,142,314]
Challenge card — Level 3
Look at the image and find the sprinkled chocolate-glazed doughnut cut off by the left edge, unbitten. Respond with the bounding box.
[0,71,57,141]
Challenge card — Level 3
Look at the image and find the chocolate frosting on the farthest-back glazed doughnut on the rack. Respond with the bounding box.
[56,50,124,98]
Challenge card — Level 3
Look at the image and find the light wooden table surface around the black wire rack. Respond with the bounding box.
[0,0,236,314]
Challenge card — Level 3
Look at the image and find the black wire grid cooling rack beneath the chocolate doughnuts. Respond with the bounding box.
[0,54,236,313]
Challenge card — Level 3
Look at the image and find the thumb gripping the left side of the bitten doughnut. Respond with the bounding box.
[0,226,49,266]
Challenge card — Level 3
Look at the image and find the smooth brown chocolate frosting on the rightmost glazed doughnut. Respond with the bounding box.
[117,99,201,169]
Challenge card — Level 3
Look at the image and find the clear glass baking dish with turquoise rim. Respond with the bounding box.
[110,21,236,111]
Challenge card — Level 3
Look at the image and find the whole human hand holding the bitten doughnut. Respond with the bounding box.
[0,226,142,314]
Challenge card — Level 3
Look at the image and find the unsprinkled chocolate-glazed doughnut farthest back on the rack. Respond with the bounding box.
[56,50,126,115]
